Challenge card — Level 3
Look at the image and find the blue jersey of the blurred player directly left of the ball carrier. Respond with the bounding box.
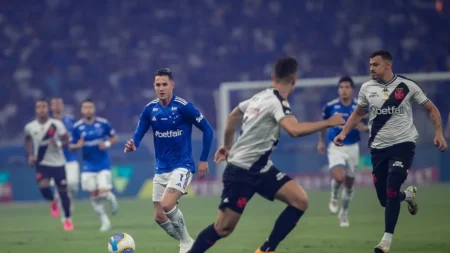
[71,117,116,172]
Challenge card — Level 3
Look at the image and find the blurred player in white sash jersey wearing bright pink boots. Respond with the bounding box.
[24,100,73,230]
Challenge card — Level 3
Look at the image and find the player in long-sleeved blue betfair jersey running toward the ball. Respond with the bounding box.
[124,68,213,253]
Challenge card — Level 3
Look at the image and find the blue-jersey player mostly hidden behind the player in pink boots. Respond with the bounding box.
[50,97,80,214]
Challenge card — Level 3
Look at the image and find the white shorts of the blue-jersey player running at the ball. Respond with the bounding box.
[152,168,192,202]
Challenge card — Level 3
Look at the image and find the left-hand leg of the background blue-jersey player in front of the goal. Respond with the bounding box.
[327,143,346,214]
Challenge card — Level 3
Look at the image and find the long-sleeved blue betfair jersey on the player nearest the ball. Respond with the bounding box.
[133,96,213,174]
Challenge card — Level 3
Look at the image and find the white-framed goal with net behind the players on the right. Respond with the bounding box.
[216,72,450,188]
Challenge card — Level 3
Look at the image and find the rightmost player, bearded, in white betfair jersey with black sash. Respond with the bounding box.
[334,50,447,253]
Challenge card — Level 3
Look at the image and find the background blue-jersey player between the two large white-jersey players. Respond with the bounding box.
[317,76,368,227]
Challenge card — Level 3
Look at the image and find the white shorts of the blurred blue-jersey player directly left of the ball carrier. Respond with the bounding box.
[81,170,112,192]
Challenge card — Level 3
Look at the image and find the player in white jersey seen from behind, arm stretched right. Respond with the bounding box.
[189,57,345,253]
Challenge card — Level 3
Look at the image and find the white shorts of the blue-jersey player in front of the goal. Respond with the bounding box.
[328,143,359,177]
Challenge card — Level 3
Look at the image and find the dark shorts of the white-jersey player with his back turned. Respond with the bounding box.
[219,164,292,214]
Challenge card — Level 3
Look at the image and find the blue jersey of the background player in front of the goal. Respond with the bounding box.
[322,98,361,145]
